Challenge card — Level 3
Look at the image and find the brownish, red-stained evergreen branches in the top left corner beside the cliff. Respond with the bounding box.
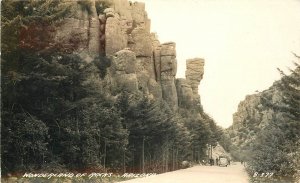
[1,0,72,69]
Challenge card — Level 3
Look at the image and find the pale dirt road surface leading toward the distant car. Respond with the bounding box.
[121,164,248,183]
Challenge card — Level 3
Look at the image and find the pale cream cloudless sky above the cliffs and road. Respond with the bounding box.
[138,0,300,127]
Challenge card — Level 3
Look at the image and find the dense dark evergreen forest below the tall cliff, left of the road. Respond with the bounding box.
[1,0,224,176]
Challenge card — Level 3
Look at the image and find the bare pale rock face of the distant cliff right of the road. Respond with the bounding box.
[228,84,283,147]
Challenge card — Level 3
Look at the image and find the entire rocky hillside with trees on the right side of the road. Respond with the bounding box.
[228,55,300,181]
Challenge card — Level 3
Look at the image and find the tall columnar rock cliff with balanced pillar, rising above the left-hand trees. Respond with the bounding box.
[33,0,204,110]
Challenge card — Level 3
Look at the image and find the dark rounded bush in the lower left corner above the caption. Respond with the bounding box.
[1,111,48,172]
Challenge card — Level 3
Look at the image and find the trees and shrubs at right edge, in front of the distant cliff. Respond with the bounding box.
[244,57,300,180]
